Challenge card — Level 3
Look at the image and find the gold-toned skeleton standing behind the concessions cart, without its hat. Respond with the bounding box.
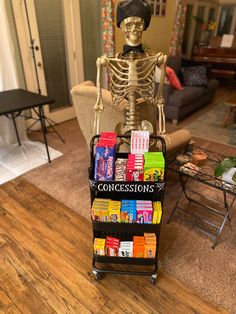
[94,11,167,135]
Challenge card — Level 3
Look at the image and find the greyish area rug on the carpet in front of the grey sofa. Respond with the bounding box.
[185,102,236,147]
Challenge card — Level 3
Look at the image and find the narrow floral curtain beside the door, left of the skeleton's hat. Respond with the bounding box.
[102,0,115,57]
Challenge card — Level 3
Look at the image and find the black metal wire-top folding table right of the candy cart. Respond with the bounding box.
[167,146,236,248]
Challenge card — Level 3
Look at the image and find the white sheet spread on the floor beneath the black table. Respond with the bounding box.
[0,141,62,184]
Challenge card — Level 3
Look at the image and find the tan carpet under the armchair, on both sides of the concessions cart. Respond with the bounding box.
[24,120,236,313]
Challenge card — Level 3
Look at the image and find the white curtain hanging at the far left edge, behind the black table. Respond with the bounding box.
[0,0,27,147]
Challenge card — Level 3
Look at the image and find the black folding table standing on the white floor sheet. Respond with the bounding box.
[0,89,54,162]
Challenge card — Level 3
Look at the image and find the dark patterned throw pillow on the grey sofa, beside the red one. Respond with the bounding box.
[180,65,207,87]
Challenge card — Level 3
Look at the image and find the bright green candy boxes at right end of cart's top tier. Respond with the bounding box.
[144,152,165,182]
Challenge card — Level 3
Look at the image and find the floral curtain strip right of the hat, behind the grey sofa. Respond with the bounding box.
[169,0,187,56]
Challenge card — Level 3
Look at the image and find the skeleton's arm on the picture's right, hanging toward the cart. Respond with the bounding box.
[155,54,167,135]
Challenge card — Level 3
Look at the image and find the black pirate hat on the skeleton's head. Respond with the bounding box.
[116,0,152,30]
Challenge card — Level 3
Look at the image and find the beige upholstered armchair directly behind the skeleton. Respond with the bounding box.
[71,81,191,155]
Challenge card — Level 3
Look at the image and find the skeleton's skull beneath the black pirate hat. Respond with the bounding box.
[120,16,144,47]
